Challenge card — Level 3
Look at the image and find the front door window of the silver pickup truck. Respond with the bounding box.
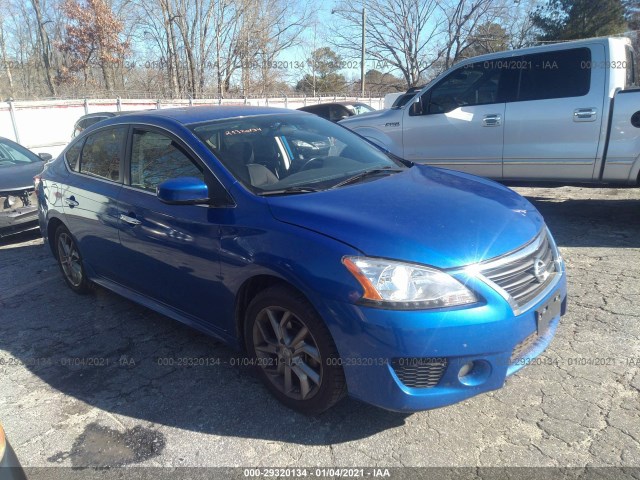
[421,62,500,114]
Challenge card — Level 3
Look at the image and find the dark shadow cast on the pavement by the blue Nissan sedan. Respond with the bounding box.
[0,243,406,448]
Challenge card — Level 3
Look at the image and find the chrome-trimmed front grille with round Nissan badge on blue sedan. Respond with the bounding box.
[481,229,558,308]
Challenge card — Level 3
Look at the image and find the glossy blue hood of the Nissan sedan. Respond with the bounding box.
[268,165,544,268]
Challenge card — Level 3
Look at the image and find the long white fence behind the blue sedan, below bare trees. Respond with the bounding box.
[0,96,384,156]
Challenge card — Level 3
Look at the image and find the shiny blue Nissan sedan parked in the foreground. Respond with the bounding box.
[36,107,566,414]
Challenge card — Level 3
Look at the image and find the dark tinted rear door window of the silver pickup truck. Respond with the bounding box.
[517,48,597,101]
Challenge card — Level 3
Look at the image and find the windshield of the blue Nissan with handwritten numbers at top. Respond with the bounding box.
[192,114,406,195]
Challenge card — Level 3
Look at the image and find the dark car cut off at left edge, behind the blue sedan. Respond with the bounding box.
[0,137,51,238]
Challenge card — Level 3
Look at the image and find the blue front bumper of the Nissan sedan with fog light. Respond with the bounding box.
[326,267,566,411]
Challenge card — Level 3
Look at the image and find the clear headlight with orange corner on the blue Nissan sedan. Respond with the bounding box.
[342,257,478,309]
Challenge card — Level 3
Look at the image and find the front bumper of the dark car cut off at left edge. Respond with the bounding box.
[0,190,38,238]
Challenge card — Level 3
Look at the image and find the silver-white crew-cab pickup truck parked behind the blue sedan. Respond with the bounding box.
[340,38,640,184]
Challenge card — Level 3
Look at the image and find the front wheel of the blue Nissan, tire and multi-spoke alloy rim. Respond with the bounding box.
[244,286,346,415]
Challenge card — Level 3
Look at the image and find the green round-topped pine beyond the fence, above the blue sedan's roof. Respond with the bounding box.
[296,47,346,95]
